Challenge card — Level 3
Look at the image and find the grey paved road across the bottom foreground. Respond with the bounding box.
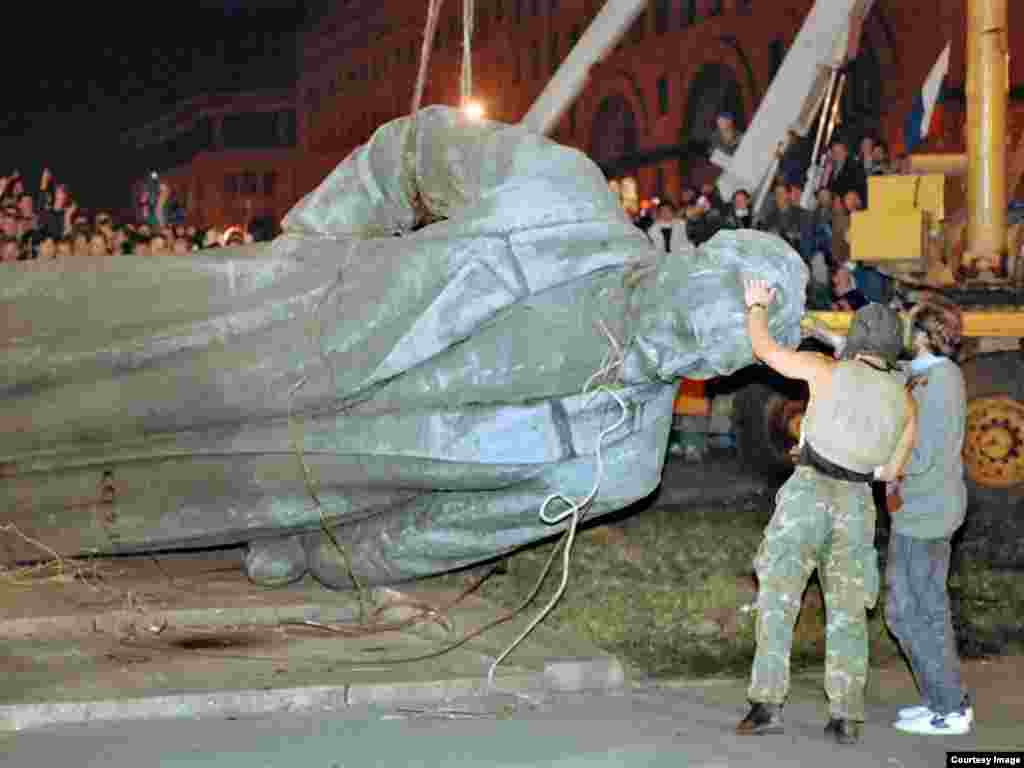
[0,688,962,768]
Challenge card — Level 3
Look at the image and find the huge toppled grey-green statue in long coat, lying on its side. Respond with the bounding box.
[0,108,807,586]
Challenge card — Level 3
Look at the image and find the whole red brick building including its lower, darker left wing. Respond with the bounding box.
[132,0,1024,226]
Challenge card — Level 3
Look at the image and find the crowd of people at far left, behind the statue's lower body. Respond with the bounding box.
[0,168,267,262]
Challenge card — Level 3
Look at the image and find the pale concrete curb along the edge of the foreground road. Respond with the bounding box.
[0,656,626,731]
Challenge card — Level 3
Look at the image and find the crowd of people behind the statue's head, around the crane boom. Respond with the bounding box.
[635,115,905,310]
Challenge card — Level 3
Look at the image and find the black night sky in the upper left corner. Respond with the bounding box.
[0,0,308,217]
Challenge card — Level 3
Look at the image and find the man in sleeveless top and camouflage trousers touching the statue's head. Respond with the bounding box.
[736,281,916,743]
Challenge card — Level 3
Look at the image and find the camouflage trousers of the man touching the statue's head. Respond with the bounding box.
[749,466,879,721]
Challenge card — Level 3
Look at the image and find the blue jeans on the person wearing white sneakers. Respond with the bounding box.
[886,532,964,715]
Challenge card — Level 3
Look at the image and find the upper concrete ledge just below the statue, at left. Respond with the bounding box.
[0,603,357,640]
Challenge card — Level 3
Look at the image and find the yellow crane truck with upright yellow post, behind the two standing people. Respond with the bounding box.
[732,0,1024,528]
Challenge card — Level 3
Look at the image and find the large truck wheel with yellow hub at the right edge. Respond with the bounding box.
[963,352,1024,567]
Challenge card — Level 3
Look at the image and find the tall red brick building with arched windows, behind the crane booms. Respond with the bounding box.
[297,0,1024,204]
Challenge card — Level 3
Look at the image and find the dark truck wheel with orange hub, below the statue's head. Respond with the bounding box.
[732,369,807,481]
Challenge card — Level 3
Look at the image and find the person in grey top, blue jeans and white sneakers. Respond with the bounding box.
[886,296,974,735]
